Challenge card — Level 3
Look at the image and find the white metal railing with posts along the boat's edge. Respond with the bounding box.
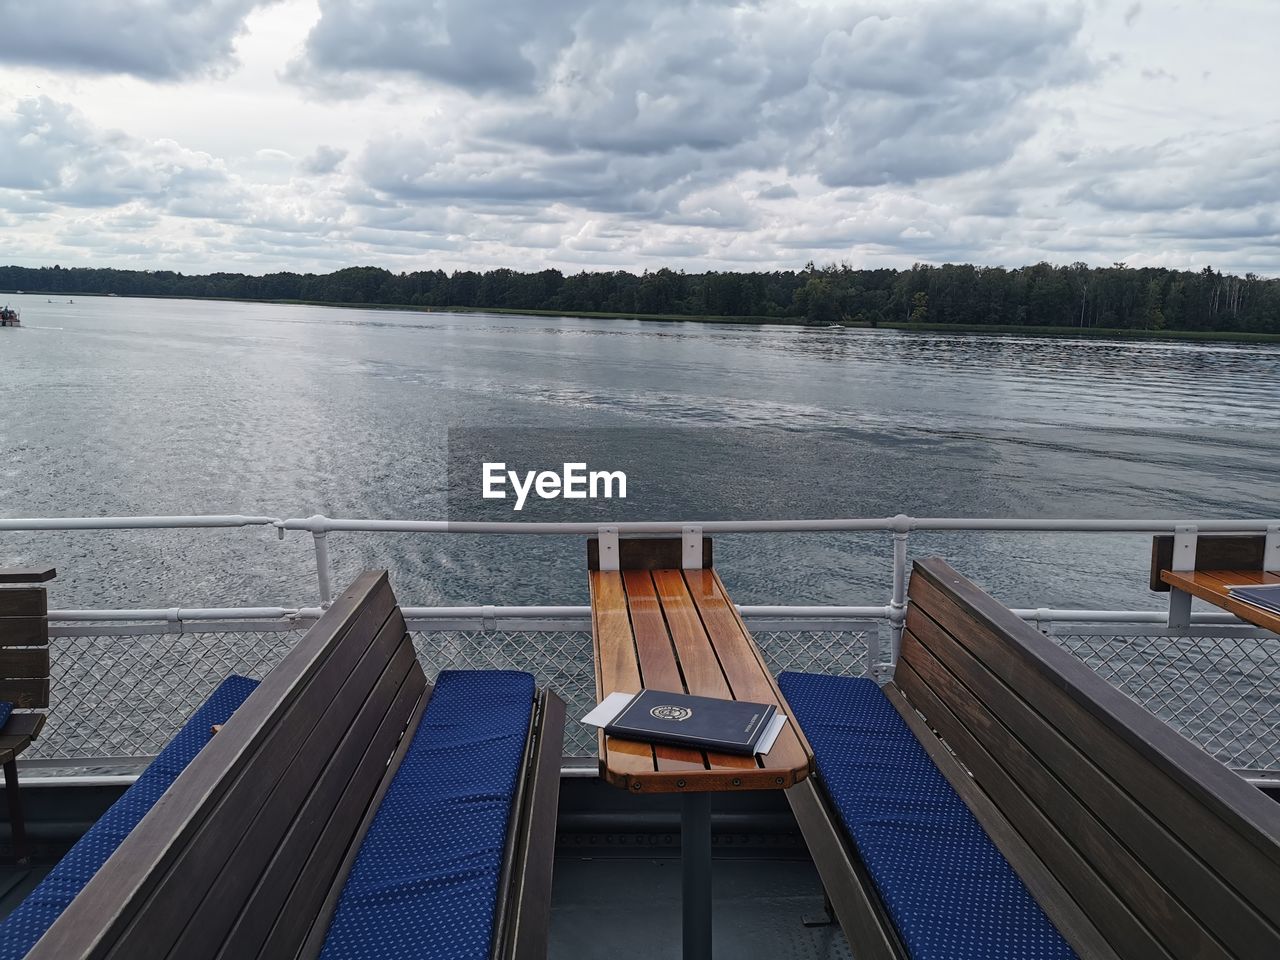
[0,515,1280,783]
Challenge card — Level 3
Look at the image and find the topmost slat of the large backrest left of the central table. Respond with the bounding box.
[27,572,396,960]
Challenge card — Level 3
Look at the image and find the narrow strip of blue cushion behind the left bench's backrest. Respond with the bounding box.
[0,675,259,960]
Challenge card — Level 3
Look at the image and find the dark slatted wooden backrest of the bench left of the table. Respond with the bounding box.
[28,572,426,960]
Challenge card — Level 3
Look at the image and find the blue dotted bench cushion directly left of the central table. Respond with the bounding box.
[320,671,534,960]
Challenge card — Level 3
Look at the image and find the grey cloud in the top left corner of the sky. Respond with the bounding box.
[0,0,274,79]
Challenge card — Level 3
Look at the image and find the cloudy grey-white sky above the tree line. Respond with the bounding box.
[0,0,1280,276]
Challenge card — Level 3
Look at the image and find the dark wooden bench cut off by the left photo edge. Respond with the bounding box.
[0,567,58,863]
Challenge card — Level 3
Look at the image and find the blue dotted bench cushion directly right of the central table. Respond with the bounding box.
[778,673,1075,960]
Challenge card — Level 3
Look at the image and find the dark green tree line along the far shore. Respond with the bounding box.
[0,262,1280,333]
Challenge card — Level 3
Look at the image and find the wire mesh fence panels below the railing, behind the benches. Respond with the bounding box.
[24,622,1280,772]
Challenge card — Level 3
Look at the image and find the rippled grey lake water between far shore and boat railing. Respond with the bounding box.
[0,296,1280,608]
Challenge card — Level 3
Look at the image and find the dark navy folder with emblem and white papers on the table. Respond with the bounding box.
[584,690,786,756]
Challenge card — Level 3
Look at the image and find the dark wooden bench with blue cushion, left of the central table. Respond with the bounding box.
[21,572,564,960]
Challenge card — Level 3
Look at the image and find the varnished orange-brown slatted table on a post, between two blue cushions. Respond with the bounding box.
[590,568,814,960]
